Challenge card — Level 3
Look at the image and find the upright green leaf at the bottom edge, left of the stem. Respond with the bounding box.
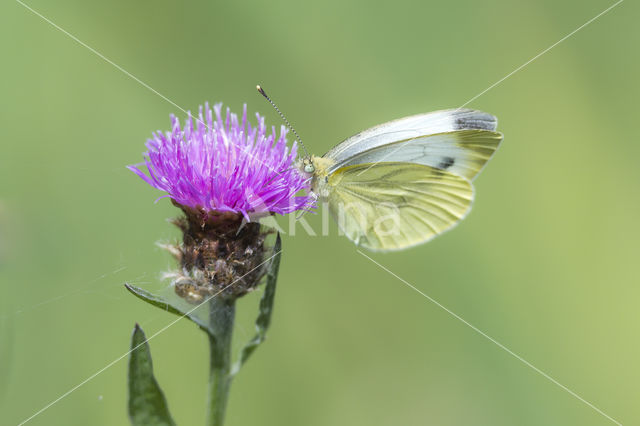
[129,324,175,426]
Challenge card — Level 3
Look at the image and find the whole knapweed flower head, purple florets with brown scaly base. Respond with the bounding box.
[129,104,314,303]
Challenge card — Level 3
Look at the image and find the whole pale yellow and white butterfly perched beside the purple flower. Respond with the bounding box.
[299,109,502,251]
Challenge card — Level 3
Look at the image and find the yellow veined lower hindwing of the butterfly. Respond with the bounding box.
[327,162,473,251]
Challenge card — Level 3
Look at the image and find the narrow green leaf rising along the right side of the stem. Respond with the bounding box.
[231,233,282,376]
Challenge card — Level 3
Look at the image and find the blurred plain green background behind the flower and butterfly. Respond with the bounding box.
[0,0,640,426]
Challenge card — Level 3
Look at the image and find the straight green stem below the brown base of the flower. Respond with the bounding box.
[207,298,236,426]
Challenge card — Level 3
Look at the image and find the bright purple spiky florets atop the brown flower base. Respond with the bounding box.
[128,104,314,220]
